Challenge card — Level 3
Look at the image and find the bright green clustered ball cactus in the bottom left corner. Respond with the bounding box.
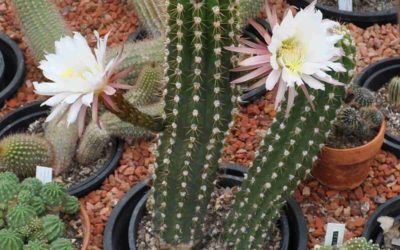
[0,172,80,250]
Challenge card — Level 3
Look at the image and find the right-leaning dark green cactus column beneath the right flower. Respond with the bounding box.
[223,25,355,250]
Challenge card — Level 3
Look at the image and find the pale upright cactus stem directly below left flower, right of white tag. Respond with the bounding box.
[44,116,79,175]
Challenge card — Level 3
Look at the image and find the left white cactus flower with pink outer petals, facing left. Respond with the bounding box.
[33,31,132,134]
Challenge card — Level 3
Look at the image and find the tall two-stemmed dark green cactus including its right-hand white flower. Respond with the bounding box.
[97,0,355,249]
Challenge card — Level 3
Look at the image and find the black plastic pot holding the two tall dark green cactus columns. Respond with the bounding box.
[103,164,308,250]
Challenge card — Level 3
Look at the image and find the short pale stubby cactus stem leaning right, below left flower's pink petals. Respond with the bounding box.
[76,121,112,165]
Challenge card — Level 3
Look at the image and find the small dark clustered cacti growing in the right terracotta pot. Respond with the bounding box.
[328,86,384,148]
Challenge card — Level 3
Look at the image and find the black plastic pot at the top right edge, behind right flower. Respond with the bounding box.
[288,0,397,28]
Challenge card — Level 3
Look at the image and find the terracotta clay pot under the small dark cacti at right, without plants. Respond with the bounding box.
[311,122,385,190]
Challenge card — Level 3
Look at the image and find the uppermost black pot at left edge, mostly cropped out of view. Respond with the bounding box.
[0,32,25,106]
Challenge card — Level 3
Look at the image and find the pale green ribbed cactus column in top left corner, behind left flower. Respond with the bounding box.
[12,0,71,61]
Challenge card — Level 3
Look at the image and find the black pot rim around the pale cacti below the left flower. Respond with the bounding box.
[0,101,123,197]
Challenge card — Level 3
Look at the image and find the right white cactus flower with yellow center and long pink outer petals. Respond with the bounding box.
[226,1,345,114]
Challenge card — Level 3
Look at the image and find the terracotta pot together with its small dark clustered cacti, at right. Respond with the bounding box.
[312,86,385,190]
